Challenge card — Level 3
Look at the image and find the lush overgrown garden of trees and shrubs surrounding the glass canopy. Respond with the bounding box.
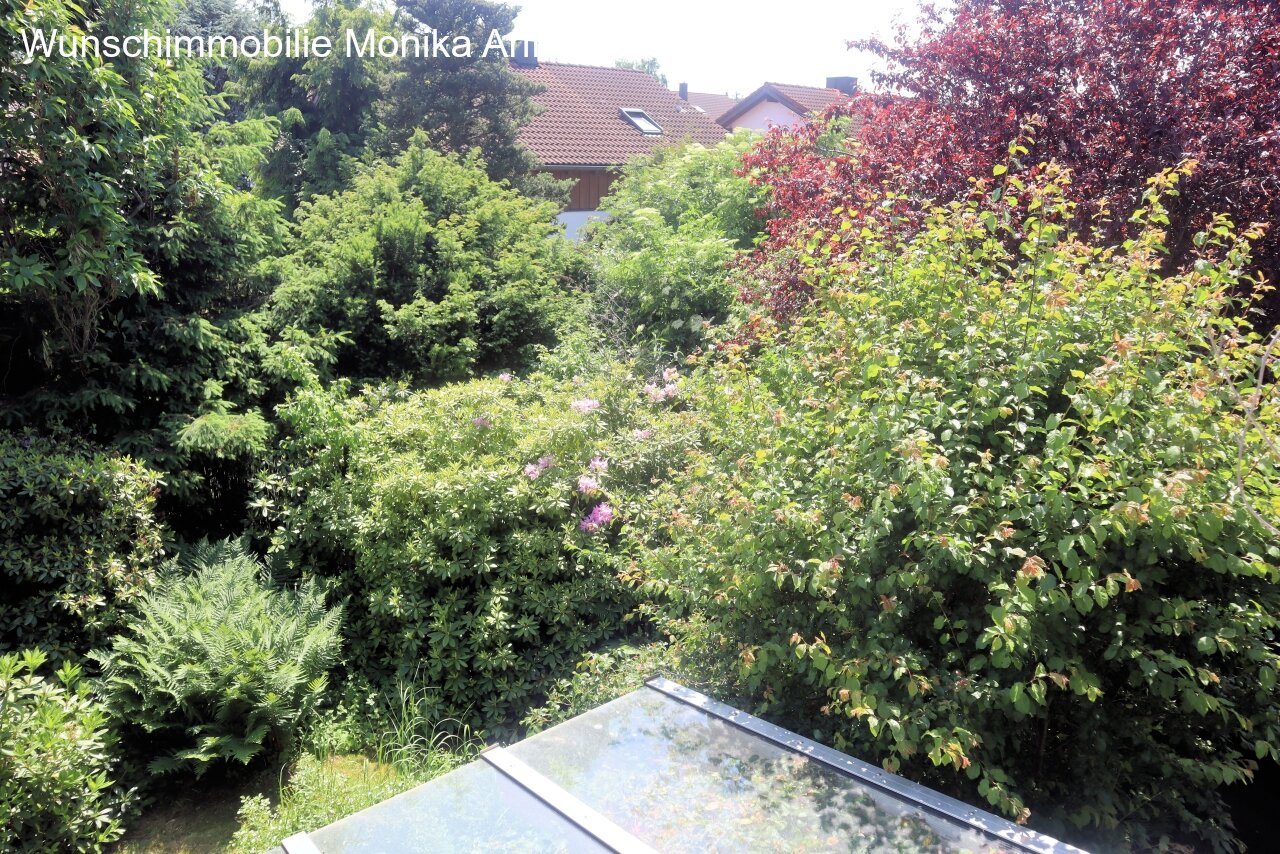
[0,0,1280,854]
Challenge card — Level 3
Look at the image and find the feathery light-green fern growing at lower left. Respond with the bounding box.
[95,543,340,773]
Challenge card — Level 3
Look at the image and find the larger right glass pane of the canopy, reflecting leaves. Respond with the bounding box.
[508,689,1015,854]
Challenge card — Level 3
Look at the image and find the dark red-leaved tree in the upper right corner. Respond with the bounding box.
[745,0,1280,324]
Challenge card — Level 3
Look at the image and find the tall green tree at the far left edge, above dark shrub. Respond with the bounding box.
[0,0,282,530]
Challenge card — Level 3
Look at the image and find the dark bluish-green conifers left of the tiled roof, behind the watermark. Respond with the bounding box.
[232,0,552,210]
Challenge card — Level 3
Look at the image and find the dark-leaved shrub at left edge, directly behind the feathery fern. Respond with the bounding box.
[0,431,164,656]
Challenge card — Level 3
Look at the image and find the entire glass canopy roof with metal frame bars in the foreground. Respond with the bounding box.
[275,677,1083,854]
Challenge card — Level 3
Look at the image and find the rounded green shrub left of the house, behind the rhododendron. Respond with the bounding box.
[268,140,567,382]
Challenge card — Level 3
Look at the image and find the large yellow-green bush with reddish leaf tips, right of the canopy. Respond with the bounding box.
[634,168,1280,849]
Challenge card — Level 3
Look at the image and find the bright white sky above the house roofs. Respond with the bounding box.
[282,0,918,95]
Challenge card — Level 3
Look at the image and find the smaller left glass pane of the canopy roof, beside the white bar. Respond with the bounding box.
[308,761,608,854]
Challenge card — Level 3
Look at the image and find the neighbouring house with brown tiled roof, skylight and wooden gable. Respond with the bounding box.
[511,54,724,237]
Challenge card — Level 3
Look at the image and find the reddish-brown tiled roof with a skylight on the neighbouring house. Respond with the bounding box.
[512,63,724,166]
